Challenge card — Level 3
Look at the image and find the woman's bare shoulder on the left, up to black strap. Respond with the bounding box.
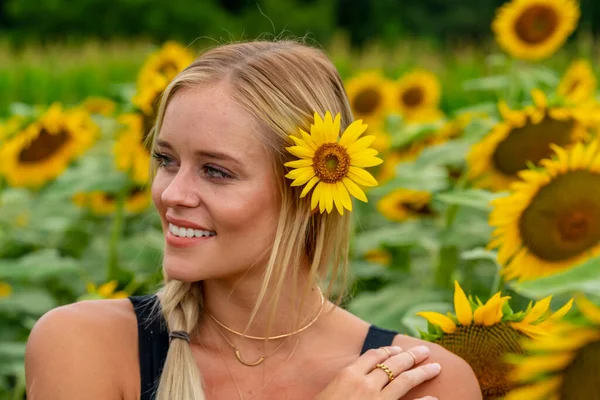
[25,299,139,400]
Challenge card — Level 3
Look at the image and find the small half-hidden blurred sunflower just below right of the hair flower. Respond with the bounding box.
[377,189,435,222]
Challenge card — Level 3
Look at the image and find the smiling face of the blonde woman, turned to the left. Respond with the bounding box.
[152,85,279,282]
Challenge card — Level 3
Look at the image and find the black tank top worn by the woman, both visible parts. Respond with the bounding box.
[129,295,398,400]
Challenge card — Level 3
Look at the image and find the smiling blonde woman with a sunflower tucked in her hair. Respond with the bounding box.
[26,41,481,400]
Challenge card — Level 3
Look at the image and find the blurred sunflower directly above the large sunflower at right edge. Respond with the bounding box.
[467,90,589,190]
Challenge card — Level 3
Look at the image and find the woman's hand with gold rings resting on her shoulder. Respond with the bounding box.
[315,346,440,400]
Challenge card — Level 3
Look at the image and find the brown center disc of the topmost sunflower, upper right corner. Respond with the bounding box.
[515,5,558,44]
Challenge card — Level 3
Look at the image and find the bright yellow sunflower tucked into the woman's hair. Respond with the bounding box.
[285,111,383,215]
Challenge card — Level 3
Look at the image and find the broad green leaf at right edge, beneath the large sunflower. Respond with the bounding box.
[510,257,600,299]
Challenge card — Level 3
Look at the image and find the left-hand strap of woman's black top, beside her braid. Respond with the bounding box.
[129,295,169,400]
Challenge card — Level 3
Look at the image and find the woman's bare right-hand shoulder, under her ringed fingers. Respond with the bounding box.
[393,335,482,400]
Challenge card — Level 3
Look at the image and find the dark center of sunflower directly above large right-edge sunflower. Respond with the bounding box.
[492,116,575,176]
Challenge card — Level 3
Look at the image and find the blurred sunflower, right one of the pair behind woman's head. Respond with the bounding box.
[392,70,443,118]
